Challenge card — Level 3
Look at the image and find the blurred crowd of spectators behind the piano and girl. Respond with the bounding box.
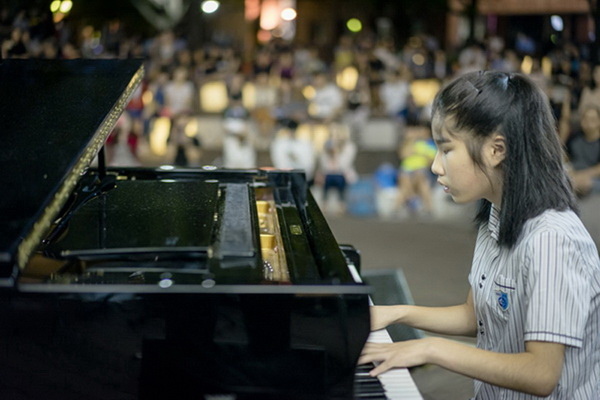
[0,4,600,215]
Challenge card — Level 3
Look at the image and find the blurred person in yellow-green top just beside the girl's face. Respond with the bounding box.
[398,126,436,214]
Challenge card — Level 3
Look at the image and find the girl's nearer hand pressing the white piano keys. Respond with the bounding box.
[358,338,435,376]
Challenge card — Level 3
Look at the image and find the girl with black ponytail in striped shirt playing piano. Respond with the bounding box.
[360,72,600,399]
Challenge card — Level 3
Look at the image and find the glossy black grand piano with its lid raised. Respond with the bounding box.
[0,60,422,399]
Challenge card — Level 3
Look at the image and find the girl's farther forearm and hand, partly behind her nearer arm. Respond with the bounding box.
[371,291,477,336]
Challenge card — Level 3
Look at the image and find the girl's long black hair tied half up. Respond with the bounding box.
[432,71,578,248]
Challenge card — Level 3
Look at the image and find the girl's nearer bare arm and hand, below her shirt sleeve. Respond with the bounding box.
[359,337,565,397]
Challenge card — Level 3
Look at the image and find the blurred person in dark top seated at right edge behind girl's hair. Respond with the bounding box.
[567,105,600,196]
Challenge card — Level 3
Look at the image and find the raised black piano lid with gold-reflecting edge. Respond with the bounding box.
[0,59,143,286]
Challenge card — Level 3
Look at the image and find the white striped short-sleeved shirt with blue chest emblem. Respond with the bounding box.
[469,207,600,400]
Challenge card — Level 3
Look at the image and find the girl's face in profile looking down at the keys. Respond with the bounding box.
[431,115,502,206]
